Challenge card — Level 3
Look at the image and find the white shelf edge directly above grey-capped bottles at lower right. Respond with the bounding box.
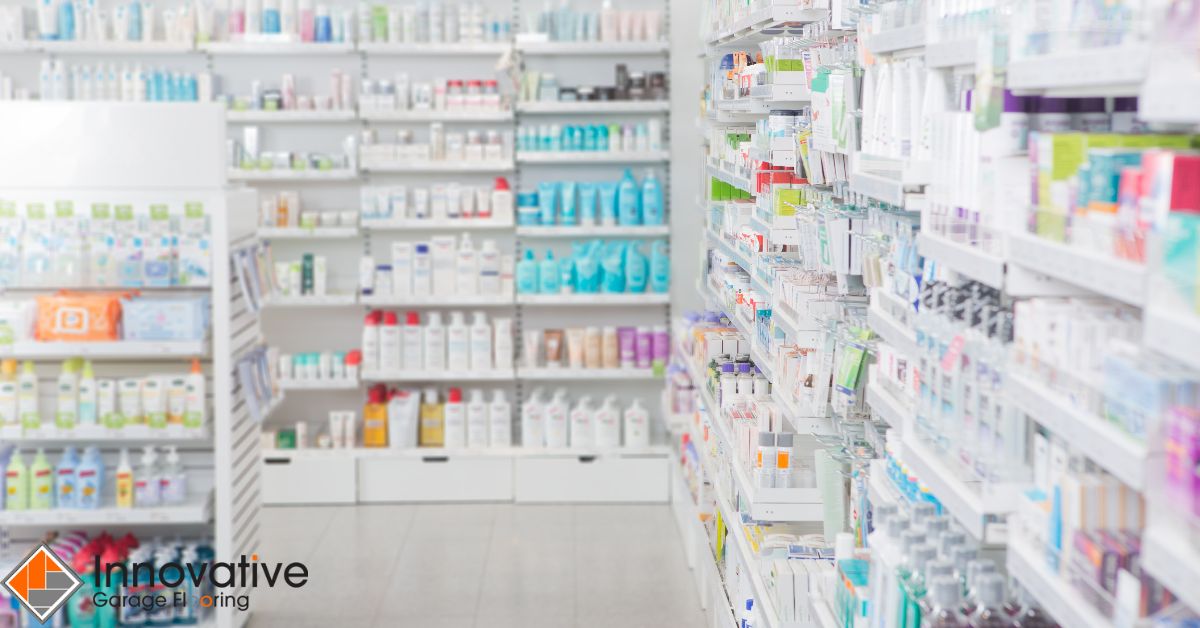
[900,433,1019,545]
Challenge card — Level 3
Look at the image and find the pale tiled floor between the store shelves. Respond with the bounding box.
[251,504,704,628]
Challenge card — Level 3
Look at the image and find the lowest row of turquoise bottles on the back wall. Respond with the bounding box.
[516,240,671,294]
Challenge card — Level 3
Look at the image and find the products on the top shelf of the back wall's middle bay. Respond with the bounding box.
[356,2,512,44]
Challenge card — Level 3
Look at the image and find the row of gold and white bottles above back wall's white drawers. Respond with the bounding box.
[362,384,512,449]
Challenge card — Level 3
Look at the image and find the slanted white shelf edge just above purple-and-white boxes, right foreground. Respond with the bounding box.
[1004,374,1147,491]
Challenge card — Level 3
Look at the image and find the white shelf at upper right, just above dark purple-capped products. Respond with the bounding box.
[1007,44,1150,96]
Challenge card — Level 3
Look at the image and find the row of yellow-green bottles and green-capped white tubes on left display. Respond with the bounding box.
[0,358,208,430]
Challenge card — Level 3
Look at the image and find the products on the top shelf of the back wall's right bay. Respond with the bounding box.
[517,1,664,42]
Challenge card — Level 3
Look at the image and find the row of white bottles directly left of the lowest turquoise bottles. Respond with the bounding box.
[359,233,514,298]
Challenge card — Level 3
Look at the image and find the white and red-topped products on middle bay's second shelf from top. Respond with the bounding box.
[359,73,509,114]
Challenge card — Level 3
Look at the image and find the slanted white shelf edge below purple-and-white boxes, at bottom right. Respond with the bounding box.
[1006,538,1112,628]
